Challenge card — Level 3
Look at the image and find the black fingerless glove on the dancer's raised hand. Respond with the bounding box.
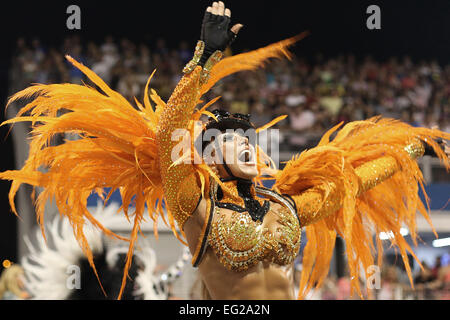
[199,12,236,66]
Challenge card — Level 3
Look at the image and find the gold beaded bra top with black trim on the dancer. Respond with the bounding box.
[194,183,301,272]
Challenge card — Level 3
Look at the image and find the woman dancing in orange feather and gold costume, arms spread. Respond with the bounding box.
[0,2,450,299]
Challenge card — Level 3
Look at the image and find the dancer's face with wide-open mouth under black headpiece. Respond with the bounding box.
[207,133,258,180]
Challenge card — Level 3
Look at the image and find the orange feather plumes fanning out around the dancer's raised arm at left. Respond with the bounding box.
[0,34,305,299]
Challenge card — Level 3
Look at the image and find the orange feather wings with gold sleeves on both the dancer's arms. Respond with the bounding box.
[0,34,450,298]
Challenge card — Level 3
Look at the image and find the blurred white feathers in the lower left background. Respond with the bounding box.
[21,203,190,300]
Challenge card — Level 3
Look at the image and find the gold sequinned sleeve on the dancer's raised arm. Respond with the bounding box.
[157,66,202,229]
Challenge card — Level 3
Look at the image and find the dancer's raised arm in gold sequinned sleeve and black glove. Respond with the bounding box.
[157,2,242,229]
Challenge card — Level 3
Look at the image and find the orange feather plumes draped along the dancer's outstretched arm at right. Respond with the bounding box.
[276,118,450,298]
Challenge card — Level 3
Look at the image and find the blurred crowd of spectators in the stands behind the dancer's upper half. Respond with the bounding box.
[9,35,450,151]
